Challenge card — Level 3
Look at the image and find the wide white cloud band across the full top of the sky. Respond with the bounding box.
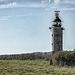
[0,0,75,10]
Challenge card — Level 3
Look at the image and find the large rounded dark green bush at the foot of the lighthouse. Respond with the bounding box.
[53,51,75,66]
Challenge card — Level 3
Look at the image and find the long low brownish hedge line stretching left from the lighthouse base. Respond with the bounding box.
[0,52,51,60]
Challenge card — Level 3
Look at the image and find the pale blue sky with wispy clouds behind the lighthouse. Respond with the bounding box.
[0,0,75,55]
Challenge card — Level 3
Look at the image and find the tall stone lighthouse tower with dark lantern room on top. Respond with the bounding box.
[49,11,64,53]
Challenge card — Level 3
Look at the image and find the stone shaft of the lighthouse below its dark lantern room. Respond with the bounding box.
[51,26,63,52]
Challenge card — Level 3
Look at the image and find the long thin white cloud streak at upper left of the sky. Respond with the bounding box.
[0,2,46,8]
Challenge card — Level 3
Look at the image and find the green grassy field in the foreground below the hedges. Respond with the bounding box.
[0,60,75,75]
